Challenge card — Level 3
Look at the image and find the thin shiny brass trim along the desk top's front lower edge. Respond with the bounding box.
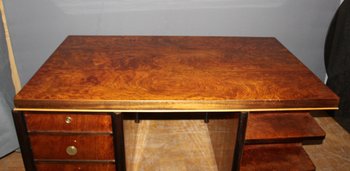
[13,107,339,113]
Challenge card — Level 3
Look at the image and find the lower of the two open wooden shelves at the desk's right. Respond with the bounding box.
[241,144,315,171]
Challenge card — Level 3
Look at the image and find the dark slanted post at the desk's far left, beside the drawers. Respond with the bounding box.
[12,111,36,171]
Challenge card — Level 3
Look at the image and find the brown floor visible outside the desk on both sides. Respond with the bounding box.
[0,113,350,171]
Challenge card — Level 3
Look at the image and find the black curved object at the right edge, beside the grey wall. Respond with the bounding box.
[324,0,350,132]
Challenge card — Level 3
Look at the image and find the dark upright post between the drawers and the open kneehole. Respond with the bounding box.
[111,113,126,171]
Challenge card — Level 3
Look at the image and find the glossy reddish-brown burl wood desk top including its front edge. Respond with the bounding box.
[15,36,338,112]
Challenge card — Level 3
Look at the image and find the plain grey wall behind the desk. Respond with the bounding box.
[3,0,339,83]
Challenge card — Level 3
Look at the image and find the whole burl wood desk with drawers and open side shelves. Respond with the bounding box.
[14,36,338,170]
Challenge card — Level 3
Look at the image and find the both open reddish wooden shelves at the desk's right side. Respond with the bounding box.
[240,112,326,171]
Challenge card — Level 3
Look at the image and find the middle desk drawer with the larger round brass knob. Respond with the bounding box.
[29,134,114,160]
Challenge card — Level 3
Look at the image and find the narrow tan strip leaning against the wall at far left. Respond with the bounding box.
[0,0,21,93]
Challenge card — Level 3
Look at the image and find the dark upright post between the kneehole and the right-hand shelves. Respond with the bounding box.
[232,112,248,171]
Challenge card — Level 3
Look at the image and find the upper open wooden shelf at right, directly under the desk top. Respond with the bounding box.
[246,112,326,144]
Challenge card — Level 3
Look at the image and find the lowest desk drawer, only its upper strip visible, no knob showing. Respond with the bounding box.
[35,162,115,171]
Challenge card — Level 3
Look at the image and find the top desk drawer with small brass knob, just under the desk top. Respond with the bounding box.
[25,112,112,133]
